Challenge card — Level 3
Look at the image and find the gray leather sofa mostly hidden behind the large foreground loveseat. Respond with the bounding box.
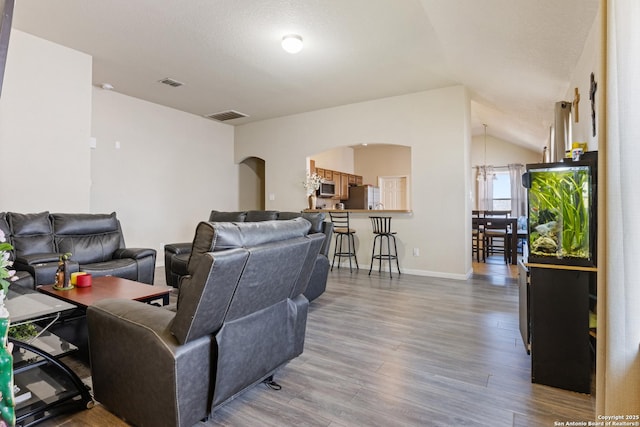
[164,210,333,301]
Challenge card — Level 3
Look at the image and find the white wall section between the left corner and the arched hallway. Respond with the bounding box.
[91,88,238,265]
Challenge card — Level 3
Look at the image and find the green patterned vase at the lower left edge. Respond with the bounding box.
[0,290,16,426]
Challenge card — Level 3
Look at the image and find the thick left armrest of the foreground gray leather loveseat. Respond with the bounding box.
[87,299,215,425]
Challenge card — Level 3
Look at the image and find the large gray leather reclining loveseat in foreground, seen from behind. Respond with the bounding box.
[87,218,324,426]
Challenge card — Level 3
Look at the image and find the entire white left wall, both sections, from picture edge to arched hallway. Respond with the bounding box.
[0,29,238,265]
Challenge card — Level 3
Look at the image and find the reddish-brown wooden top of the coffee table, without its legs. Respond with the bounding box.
[38,276,173,309]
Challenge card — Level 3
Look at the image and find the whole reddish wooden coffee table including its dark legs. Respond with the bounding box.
[36,276,173,362]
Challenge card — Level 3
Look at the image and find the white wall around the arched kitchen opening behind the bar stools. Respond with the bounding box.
[235,86,471,278]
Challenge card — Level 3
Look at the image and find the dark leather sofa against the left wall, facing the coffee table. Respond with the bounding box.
[0,212,156,288]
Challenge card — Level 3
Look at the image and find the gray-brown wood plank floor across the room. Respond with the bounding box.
[53,261,594,427]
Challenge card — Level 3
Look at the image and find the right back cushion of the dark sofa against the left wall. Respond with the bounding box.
[51,212,122,265]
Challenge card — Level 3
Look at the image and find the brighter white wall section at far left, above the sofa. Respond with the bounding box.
[0,29,91,212]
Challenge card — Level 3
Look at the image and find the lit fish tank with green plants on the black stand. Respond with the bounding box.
[524,155,597,266]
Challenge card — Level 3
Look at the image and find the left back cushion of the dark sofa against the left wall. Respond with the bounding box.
[7,212,56,256]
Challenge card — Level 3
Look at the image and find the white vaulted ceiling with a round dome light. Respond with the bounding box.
[13,0,599,149]
